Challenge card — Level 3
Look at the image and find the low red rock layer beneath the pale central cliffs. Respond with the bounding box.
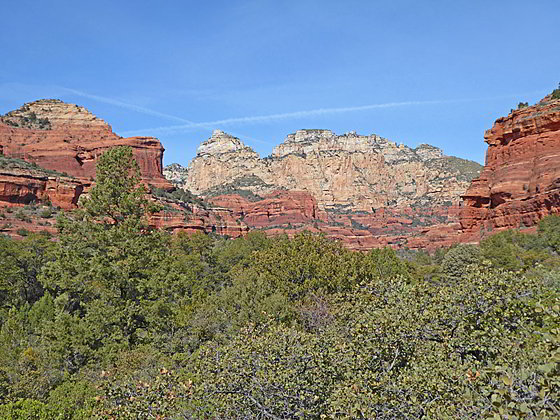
[208,190,460,251]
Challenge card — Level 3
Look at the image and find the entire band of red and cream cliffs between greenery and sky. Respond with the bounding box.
[4,96,560,250]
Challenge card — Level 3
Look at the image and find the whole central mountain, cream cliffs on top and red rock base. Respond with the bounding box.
[165,126,481,250]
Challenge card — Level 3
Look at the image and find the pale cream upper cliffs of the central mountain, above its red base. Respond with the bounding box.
[179,130,481,212]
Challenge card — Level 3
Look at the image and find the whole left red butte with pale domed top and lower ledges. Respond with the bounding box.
[0,99,248,237]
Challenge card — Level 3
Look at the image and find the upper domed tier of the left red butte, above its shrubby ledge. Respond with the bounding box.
[0,99,172,189]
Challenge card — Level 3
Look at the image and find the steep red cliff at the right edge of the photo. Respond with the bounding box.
[461,96,560,240]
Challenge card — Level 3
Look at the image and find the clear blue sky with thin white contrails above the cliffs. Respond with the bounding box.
[0,0,560,164]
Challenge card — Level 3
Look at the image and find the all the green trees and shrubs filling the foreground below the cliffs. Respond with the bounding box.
[0,148,560,420]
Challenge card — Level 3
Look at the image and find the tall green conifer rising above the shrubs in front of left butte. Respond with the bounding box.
[41,147,172,372]
